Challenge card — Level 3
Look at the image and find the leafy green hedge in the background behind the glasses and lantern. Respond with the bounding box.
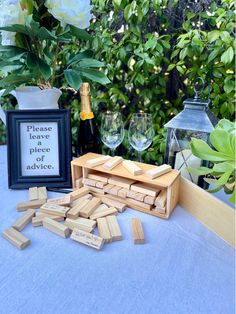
[0,0,234,163]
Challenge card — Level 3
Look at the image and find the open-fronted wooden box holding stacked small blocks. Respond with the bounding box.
[71,153,180,219]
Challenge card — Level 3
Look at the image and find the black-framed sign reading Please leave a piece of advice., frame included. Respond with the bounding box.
[6,109,71,189]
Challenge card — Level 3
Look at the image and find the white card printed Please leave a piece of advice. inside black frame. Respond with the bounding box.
[20,122,59,176]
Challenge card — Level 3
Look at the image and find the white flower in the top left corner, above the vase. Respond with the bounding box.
[0,0,24,46]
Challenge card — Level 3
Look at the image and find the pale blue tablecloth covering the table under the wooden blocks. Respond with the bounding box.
[0,146,235,314]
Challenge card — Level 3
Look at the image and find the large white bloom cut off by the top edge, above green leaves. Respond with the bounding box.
[45,0,92,29]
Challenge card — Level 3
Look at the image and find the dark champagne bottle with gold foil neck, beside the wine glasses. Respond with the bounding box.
[77,83,98,156]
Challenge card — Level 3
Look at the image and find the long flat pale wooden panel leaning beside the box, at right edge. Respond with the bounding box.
[179,177,235,247]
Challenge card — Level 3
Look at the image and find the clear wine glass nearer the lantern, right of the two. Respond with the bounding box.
[128,112,154,162]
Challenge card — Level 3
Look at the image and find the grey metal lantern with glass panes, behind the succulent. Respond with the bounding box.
[165,78,218,188]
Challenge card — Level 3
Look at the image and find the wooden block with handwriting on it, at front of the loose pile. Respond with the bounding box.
[71,228,104,250]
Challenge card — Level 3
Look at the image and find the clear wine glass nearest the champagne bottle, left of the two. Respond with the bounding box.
[100,111,124,156]
